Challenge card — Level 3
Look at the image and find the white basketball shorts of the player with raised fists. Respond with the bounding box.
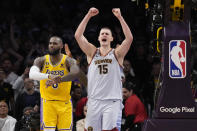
[85,99,122,131]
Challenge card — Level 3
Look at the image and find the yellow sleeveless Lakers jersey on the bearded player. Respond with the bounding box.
[40,55,71,102]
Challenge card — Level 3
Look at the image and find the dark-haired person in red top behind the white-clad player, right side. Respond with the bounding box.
[122,82,147,131]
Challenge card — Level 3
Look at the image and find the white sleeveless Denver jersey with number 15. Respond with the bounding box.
[88,49,122,100]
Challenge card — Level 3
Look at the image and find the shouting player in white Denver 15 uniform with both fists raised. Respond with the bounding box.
[75,8,133,131]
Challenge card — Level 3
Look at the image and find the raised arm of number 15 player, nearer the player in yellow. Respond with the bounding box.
[75,8,99,59]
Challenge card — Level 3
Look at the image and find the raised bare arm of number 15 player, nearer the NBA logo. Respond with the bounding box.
[112,8,133,64]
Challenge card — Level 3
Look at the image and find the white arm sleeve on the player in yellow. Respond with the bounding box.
[29,66,49,81]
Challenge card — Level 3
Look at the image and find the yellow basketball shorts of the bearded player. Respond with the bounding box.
[40,99,73,131]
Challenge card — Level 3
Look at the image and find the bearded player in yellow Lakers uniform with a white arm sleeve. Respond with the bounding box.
[29,36,87,131]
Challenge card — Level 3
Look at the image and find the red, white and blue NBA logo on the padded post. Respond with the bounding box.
[169,40,186,78]
